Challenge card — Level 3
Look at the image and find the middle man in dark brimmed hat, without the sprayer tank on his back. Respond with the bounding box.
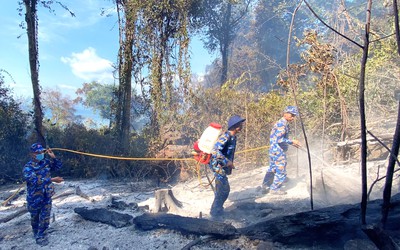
[210,115,246,217]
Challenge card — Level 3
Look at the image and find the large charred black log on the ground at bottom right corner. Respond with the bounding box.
[238,194,400,249]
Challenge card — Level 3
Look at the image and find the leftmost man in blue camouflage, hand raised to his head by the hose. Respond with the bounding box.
[23,143,64,246]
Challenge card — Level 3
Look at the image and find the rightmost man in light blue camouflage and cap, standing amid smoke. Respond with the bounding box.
[262,106,300,195]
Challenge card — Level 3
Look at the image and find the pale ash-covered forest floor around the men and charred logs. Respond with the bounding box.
[0,151,400,250]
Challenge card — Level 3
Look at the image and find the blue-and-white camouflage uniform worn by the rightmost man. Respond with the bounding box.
[263,118,293,190]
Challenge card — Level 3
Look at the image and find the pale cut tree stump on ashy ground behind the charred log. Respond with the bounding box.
[153,189,183,213]
